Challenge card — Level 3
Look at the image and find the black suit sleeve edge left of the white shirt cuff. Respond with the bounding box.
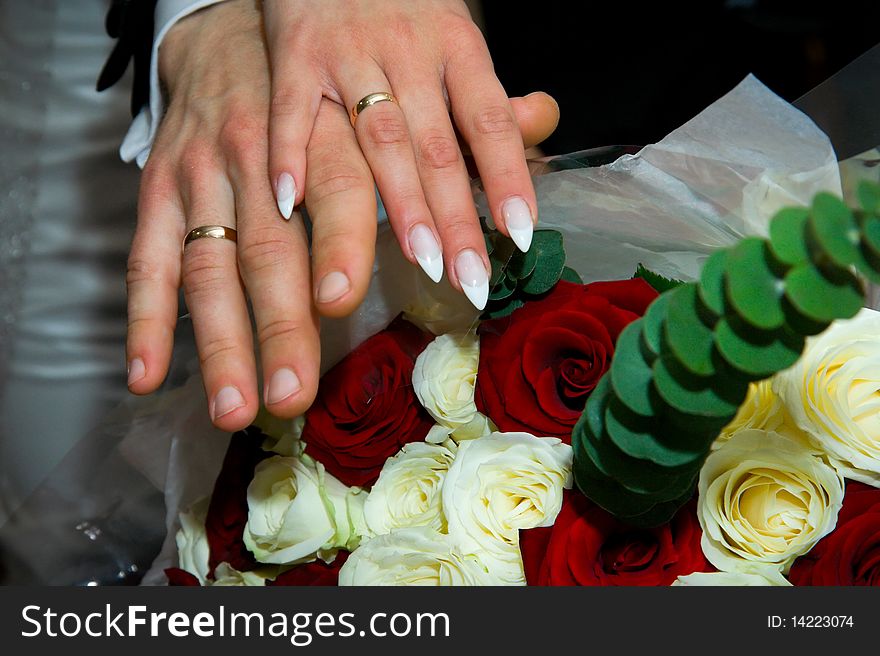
[97,0,157,116]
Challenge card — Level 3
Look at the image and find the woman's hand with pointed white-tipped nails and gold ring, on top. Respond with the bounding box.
[264,0,537,316]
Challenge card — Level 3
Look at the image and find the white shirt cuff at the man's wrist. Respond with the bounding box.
[119,0,230,168]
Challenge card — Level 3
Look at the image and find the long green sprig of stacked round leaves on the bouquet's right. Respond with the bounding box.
[572,183,880,526]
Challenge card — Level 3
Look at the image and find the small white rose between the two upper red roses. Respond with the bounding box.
[412,332,492,442]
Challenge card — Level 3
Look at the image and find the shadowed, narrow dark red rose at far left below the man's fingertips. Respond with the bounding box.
[205,426,272,576]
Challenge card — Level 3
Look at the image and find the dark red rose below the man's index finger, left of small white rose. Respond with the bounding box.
[303,317,434,486]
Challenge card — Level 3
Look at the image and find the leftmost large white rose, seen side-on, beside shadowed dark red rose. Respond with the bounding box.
[244,455,364,564]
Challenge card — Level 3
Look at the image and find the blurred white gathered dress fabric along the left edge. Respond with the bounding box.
[0,0,139,525]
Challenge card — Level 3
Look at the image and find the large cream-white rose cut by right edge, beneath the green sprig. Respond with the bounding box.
[775,309,880,487]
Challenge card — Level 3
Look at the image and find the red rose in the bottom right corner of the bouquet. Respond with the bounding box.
[788,481,880,585]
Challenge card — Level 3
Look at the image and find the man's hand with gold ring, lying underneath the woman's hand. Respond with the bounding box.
[127,0,558,431]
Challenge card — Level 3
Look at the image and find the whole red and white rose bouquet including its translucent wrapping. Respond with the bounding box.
[0,79,877,585]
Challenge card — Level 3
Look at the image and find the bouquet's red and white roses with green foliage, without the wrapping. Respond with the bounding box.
[162,173,880,585]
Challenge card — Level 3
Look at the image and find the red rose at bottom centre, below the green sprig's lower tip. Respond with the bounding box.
[520,491,711,586]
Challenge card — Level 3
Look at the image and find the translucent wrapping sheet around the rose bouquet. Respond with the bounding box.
[0,77,841,584]
